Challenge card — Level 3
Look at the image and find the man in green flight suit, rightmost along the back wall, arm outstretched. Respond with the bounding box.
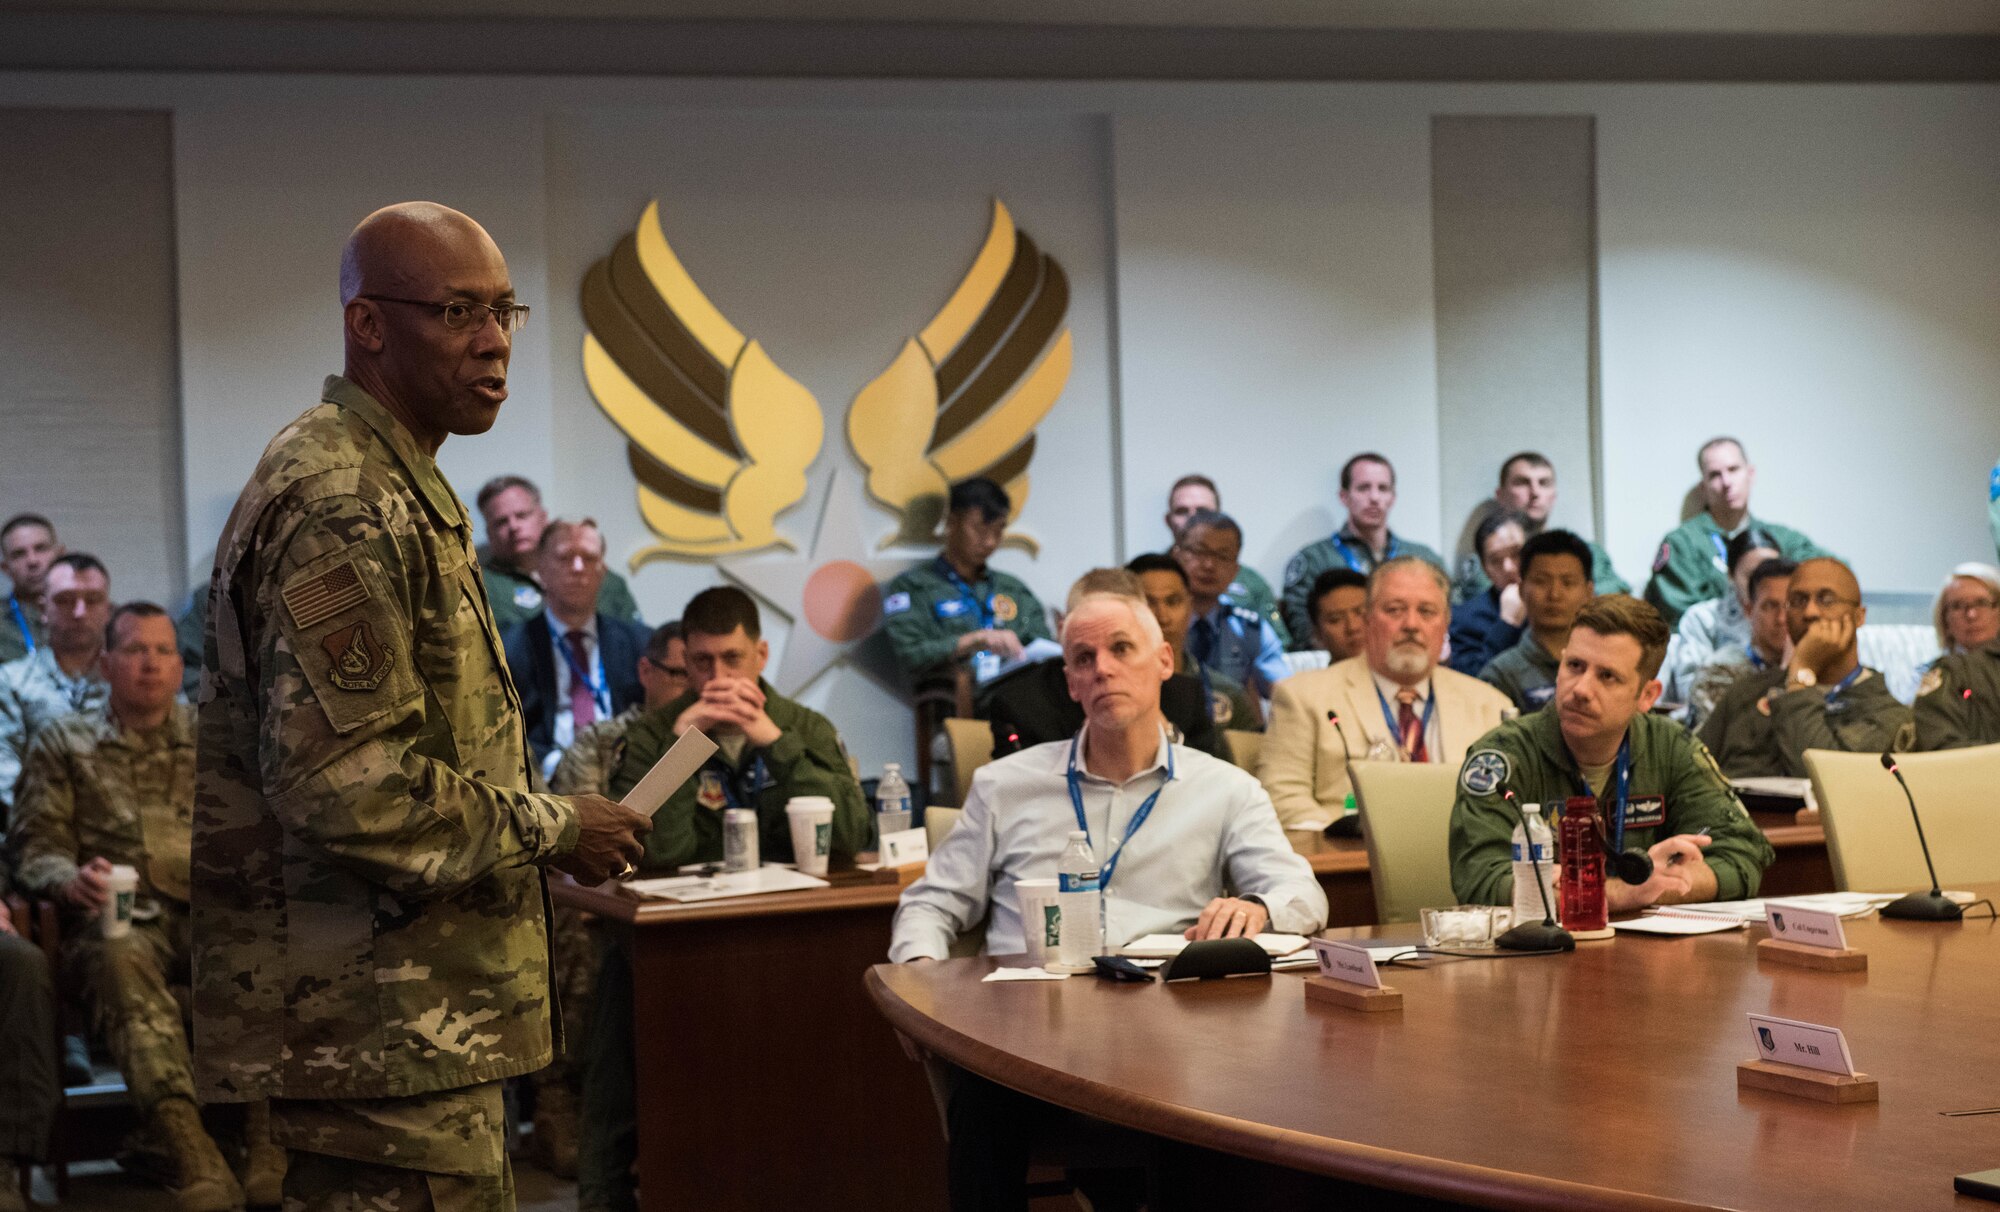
[1646,438,1832,626]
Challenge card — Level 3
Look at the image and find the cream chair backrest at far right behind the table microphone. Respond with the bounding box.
[1806,744,2000,892]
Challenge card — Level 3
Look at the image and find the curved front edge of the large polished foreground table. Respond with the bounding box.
[862,964,1718,1212]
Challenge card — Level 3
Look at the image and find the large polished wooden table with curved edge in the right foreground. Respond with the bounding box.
[868,886,2000,1212]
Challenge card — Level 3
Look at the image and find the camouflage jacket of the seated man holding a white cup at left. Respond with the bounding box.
[8,702,194,918]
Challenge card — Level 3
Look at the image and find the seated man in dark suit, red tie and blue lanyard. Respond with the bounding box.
[504,518,646,778]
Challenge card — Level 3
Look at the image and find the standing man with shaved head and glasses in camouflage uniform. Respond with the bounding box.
[190,202,648,1212]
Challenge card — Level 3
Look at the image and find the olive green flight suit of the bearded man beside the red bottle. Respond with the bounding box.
[1450,712,1774,904]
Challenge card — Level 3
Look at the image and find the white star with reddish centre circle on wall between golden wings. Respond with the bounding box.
[718,468,916,698]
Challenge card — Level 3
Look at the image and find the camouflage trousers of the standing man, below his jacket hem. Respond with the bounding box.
[270,1082,514,1212]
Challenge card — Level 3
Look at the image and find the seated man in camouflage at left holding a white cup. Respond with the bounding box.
[8,602,284,1212]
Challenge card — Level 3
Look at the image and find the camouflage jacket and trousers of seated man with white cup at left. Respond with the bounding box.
[8,702,194,1116]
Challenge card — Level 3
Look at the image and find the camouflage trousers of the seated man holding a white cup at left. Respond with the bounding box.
[62,904,196,1114]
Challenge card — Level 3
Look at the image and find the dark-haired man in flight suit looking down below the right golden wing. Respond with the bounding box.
[882,476,1050,682]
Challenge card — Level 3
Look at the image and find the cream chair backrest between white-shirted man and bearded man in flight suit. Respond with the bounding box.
[1348,762,1458,926]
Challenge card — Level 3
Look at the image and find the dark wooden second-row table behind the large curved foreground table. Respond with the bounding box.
[552,818,1832,1212]
